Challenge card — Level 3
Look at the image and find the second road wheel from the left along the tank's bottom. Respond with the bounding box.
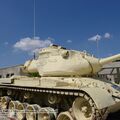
[8,101,19,119]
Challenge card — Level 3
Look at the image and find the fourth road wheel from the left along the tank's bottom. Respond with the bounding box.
[26,104,41,120]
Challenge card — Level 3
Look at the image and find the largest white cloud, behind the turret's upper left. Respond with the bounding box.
[13,37,52,53]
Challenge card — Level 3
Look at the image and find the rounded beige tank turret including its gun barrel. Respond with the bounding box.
[24,45,120,76]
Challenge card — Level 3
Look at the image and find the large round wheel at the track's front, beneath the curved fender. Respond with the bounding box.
[72,97,94,120]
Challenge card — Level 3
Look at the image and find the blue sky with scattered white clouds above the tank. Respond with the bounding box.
[0,0,120,67]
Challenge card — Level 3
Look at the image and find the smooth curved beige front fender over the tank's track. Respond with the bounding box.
[80,88,115,109]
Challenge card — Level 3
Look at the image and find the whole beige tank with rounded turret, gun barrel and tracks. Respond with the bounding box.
[0,45,120,120]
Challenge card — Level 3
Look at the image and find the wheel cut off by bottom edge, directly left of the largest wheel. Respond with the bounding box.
[57,111,74,120]
